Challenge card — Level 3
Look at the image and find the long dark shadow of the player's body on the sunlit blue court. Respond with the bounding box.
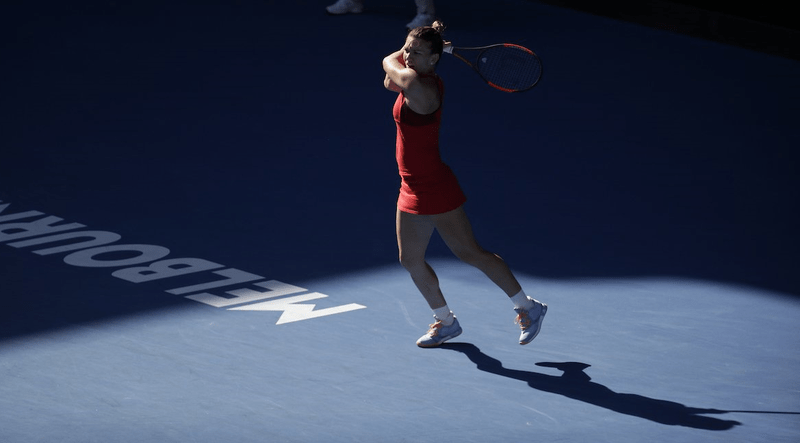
[441,343,741,431]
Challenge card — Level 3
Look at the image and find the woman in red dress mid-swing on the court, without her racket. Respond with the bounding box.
[383,21,547,347]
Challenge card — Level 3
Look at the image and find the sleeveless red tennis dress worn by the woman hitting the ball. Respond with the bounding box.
[392,77,467,215]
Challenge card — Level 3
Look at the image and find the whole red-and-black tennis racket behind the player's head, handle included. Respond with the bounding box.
[444,43,542,92]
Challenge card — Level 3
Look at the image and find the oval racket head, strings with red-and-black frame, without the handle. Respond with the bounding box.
[476,46,542,91]
